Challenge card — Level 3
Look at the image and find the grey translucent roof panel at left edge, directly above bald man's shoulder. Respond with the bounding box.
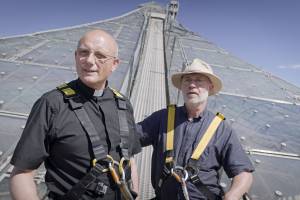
[0,62,76,113]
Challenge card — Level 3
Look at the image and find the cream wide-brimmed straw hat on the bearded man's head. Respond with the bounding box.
[172,58,222,95]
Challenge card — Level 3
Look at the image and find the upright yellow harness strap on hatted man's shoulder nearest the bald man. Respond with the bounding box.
[166,105,176,163]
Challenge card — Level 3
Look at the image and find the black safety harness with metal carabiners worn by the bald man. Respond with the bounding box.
[57,84,135,200]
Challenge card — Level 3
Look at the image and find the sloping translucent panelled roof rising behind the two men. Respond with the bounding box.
[0,3,300,199]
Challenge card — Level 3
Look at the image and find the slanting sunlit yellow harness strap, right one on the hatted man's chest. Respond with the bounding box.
[191,113,225,160]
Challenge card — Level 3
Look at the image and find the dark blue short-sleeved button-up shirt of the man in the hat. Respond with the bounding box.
[137,106,254,199]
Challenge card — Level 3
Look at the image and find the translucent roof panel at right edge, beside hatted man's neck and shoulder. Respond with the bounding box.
[209,95,300,153]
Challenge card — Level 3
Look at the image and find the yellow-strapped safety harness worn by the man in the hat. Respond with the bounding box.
[156,105,225,200]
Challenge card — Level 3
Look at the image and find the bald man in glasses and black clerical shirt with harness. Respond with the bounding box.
[10,30,141,200]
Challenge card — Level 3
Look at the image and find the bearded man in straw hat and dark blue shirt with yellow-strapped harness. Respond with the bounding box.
[137,59,254,200]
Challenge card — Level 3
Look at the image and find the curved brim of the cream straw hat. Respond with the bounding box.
[171,72,222,96]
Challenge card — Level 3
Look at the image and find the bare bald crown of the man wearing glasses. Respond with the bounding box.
[77,29,118,58]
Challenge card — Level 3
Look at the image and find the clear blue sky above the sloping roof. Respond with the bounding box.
[0,0,300,87]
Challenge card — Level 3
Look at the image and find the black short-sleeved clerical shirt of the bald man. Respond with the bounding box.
[11,80,141,198]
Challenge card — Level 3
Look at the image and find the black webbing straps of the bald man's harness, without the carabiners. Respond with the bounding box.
[57,84,132,200]
